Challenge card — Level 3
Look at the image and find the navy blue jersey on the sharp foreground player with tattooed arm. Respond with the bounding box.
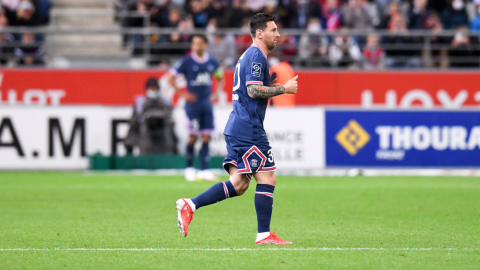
[224,44,270,141]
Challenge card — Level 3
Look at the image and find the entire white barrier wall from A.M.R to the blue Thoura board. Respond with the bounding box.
[0,106,325,170]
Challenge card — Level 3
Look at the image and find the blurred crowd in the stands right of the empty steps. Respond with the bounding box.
[119,0,480,69]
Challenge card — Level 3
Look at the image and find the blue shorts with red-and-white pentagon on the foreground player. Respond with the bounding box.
[223,135,276,180]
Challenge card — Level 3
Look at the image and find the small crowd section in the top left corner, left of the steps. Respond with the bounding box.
[0,0,50,66]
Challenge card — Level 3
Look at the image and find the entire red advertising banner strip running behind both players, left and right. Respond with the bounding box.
[0,69,480,108]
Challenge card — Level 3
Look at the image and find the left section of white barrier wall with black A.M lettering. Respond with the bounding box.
[0,106,131,169]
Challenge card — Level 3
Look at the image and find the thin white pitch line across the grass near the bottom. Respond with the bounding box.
[0,247,479,251]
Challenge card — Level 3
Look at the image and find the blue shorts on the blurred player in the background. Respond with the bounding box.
[185,104,215,135]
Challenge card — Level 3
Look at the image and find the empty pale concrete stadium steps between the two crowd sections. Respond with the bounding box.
[46,0,142,68]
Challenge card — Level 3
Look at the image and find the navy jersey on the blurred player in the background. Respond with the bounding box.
[170,53,223,105]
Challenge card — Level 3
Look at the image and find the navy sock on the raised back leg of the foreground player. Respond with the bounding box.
[192,181,237,209]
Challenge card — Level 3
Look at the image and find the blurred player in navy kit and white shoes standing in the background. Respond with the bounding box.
[168,35,224,181]
